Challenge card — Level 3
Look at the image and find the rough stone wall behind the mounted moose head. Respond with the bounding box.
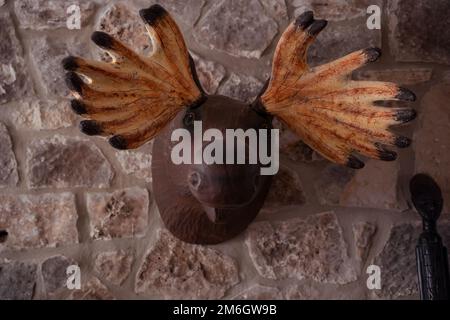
[0,0,450,299]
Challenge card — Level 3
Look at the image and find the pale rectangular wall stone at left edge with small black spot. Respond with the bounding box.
[0,192,78,249]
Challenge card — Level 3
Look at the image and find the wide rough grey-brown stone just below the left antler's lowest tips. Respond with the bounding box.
[27,135,114,188]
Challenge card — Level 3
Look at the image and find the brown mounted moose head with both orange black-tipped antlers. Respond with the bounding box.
[63,5,416,244]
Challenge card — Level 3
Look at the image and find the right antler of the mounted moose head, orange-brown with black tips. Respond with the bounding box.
[254,11,416,169]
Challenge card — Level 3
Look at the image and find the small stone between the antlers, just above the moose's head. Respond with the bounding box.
[219,73,264,103]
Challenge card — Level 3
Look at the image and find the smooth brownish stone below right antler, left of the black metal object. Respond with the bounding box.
[339,160,408,210]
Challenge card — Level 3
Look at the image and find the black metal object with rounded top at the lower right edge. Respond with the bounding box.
[409,174,450,300]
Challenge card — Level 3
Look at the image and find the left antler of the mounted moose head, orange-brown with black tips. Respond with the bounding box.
[63,5,204,149]
